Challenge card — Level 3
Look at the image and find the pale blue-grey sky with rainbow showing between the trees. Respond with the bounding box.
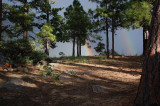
[5,0,143,57]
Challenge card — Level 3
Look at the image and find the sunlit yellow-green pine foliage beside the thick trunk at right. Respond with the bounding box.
[123,0,152,28]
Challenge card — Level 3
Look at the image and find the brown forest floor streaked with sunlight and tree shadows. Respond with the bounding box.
[0,56,143,106]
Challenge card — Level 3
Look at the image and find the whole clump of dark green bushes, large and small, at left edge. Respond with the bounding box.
[0,39,48,65]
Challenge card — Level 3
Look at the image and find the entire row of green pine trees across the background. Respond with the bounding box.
[0,0,152,58]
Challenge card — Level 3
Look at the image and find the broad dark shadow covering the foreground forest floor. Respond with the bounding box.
[0,68,138,106]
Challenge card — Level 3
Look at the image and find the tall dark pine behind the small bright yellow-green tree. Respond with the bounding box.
[31,0,64,55]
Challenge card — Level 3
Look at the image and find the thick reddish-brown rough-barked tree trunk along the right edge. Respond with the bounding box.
[134,0,160,106]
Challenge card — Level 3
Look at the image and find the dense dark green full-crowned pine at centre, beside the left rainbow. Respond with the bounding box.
[64,0,90,56]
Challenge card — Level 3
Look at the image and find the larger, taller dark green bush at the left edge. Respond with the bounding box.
[0,39,35,64]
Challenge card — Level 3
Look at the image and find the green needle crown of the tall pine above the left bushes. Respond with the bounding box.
[3,0,35,38]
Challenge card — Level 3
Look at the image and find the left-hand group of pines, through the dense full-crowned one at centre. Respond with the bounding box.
[0,0,91,56]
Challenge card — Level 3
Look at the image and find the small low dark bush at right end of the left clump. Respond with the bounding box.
[29,50,48,63]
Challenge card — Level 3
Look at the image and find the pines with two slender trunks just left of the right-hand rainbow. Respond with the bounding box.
[90,0,128,58]
